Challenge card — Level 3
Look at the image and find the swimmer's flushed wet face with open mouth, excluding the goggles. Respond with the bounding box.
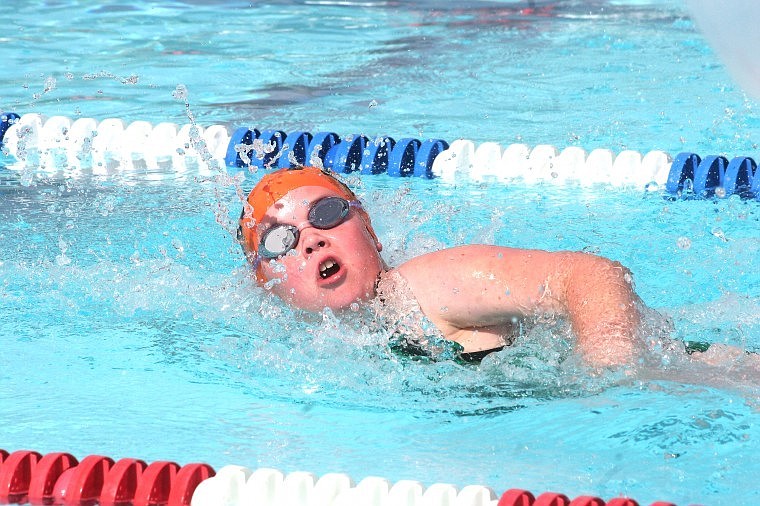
[257,186,383,311]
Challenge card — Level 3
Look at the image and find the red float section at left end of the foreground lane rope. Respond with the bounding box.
[0,450,216,506]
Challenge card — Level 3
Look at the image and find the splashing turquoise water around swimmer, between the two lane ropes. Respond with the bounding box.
[0,168,760,501]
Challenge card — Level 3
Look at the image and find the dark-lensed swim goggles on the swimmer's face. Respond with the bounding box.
[258,197,361,258]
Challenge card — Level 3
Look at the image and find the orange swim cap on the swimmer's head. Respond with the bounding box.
[238,167,377,283]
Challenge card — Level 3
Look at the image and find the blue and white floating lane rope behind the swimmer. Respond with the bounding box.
[0,113,760,199]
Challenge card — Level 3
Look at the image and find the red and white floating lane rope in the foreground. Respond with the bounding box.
[0,449,676,506]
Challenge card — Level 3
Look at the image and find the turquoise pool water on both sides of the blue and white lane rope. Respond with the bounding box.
[0,2,760,504]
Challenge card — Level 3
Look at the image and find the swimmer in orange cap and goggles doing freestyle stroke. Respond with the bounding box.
[238,167,641,367]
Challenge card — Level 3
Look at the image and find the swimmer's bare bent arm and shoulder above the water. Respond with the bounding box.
[399,245,638,365]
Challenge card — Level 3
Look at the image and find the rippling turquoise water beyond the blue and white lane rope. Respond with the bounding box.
[0,0,760,154]
